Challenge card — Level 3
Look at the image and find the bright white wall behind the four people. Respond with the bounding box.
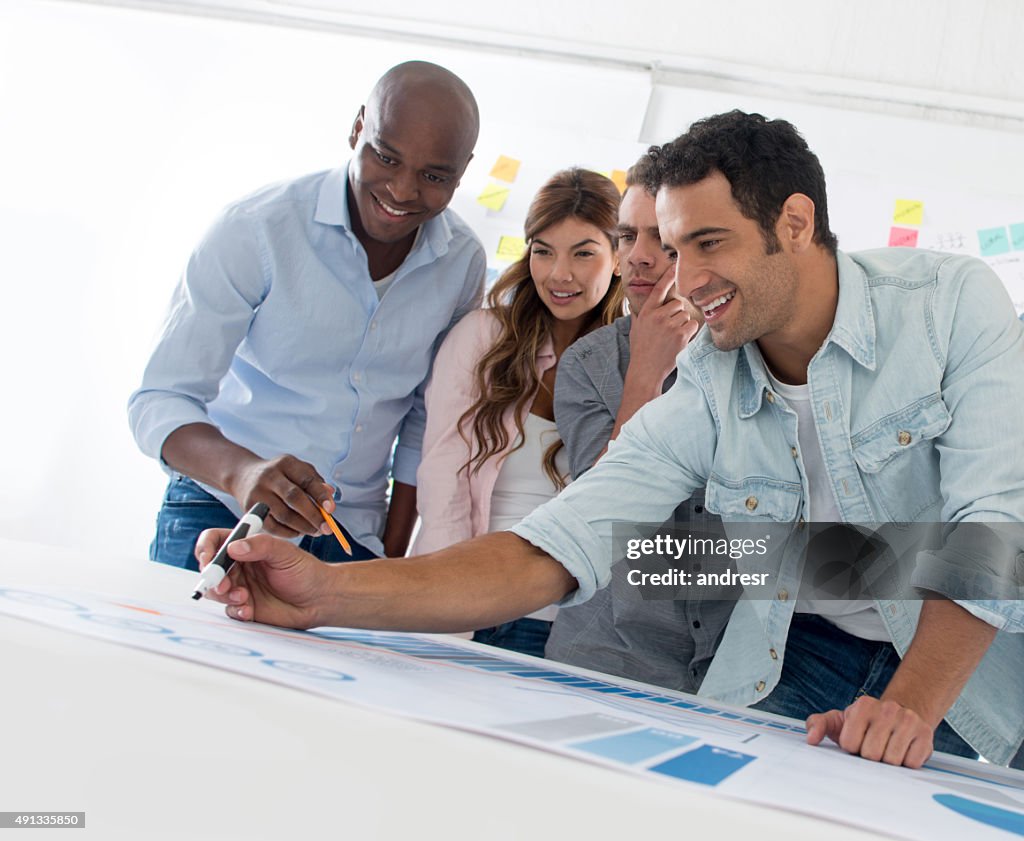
[0,0,1024,558]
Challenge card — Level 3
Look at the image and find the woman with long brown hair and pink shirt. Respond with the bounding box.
[413,168,623,656]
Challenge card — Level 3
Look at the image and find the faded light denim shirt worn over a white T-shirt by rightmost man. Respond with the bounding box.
[513,249,1024,763]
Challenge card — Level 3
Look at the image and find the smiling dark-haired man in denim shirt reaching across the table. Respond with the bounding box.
[200,112,1024,766]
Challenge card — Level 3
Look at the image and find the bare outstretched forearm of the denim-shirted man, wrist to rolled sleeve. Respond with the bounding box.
[318,532,577,633]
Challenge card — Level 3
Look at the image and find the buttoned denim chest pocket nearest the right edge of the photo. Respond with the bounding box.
[850,392,952,522]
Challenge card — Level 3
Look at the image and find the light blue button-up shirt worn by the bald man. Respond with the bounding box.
[128,166,485,553]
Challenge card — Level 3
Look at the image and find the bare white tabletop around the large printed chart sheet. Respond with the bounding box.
[0,540,878,841]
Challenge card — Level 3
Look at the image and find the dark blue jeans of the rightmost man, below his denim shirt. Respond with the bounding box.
[754,614,978,759]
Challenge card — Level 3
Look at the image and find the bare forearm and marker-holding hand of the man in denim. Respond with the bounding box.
[196,529,577,633]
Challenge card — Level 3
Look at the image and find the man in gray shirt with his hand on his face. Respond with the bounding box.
[545,155,740,692]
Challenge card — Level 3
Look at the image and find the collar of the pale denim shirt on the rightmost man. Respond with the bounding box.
[735,251,876,418]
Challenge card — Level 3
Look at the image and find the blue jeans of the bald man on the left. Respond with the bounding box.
[150,474,377,570]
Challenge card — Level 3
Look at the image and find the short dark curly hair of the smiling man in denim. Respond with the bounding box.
[641,111,839,254]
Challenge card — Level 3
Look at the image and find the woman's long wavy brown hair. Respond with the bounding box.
[459,167,624,490]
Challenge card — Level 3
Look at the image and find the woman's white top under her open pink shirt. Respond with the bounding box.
[489,415,569,622]
